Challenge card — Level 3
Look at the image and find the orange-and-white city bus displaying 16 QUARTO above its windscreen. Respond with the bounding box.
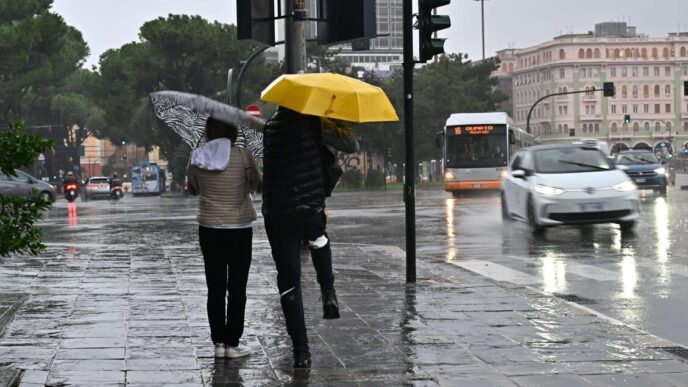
[440,112,533,194]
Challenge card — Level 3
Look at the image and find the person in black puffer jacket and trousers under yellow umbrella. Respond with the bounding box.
[262,106,339,368]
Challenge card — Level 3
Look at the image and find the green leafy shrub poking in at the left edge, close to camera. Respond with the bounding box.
[0,123,53,256]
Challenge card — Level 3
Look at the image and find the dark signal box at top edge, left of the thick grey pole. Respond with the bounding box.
[237,0,275,46]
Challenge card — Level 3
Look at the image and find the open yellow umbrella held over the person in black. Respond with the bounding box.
[260,73,399,122]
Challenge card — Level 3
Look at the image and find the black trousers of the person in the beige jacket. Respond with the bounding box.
[198,226,253,347]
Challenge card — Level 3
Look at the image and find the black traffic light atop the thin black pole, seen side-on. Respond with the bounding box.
[418,0,451,62]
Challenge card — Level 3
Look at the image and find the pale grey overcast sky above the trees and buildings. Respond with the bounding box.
[53,0,688,67]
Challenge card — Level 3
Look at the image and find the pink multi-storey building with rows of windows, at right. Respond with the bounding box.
[494,23,688,150]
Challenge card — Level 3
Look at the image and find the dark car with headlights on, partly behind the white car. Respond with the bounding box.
[614,150,675,195]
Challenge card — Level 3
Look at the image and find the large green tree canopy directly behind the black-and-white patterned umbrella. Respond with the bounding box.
[90,15,279,168]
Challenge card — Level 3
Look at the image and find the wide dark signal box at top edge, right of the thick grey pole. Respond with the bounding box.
[318,0,377,45]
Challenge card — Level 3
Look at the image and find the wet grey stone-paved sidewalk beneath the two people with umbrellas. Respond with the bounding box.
[0,235,688,386]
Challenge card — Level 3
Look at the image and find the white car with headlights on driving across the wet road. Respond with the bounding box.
[501,144,640,233]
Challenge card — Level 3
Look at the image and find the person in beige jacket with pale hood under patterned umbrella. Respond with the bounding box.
[187,117,261,358]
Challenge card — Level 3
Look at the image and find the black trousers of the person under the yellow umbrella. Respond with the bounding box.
[265,211,334,350]
